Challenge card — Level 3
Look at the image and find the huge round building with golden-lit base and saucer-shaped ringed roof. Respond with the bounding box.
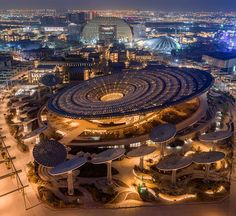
[39,68,213,146]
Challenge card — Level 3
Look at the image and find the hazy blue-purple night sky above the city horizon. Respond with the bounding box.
[0,0,236,11]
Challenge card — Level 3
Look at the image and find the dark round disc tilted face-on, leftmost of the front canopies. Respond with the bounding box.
[33,140,67,167]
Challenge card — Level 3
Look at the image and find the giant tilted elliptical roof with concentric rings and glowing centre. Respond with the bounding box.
[47,68,213,119]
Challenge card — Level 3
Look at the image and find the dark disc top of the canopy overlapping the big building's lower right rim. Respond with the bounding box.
[149,124,176,143]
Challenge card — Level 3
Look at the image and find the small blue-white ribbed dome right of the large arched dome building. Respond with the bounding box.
[137,36,180,53]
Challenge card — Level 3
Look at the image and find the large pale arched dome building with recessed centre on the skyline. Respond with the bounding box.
[81,17,133,44]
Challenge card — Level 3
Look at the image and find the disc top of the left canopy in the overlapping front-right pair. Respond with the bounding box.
[156,155,193,171]
